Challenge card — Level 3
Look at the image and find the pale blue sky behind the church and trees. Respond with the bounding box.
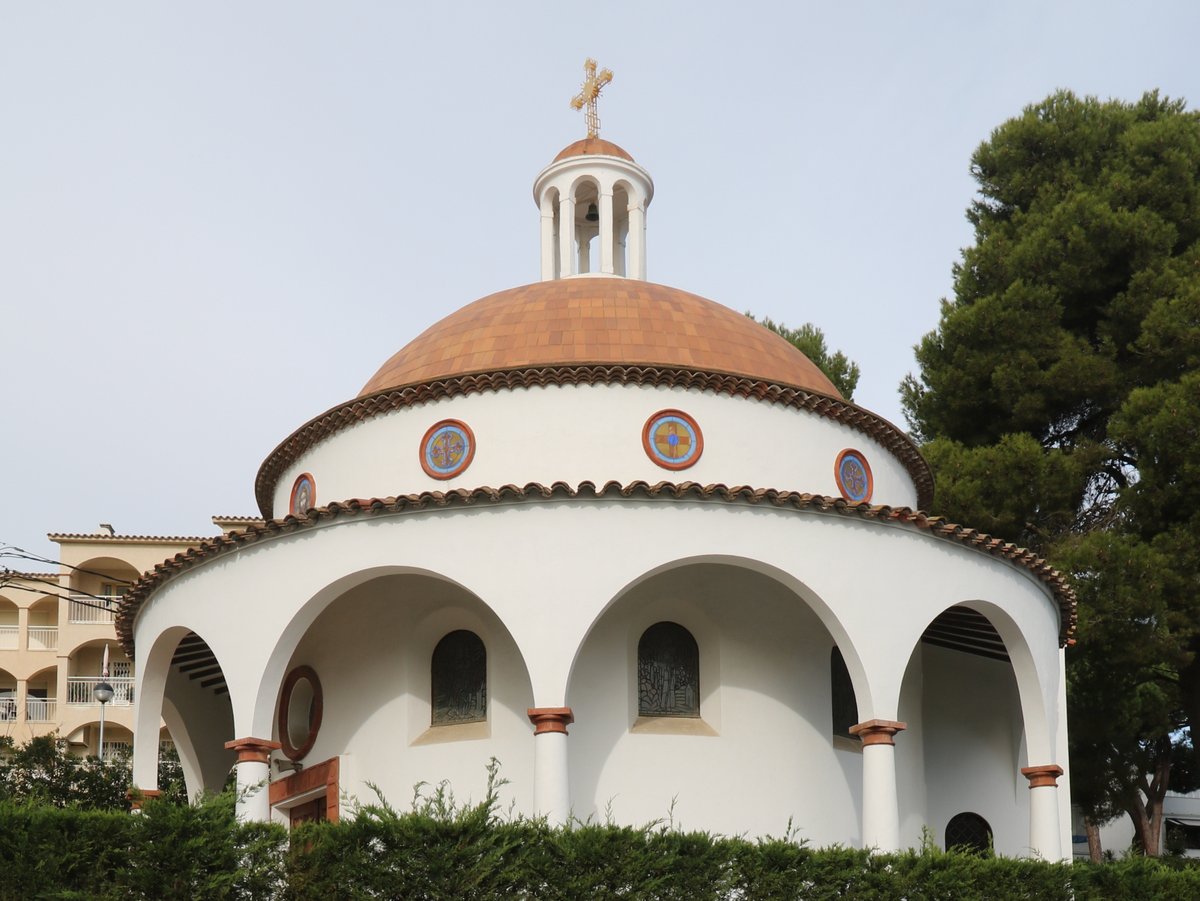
[0,0,1200,563]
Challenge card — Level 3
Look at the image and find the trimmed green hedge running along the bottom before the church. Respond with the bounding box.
[0,795,1200,901]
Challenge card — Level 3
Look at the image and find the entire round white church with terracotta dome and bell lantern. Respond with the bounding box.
[118,72,1075,859]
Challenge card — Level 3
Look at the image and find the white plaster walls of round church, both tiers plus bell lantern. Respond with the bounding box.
[121,133,1070,859]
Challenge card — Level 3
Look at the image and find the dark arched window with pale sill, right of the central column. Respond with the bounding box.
[637,623,700,716]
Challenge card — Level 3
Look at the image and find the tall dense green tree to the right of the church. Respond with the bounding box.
[901,91,1200,853]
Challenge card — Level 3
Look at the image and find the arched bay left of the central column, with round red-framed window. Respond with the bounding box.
[254,566,533,813]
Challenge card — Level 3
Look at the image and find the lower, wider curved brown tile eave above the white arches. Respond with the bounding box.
[116,481,1078,660]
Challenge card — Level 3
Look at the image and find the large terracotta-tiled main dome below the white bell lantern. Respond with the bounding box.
[359,277,841,397]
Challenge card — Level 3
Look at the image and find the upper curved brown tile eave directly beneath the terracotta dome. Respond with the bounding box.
[254,365,934,519]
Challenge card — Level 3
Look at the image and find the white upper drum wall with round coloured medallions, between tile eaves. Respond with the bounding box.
[274,385,917,516]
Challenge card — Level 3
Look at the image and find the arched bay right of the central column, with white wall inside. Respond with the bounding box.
[566,555,863,843]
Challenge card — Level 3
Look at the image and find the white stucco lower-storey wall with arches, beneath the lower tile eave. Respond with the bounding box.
[136,496,1066,847]
